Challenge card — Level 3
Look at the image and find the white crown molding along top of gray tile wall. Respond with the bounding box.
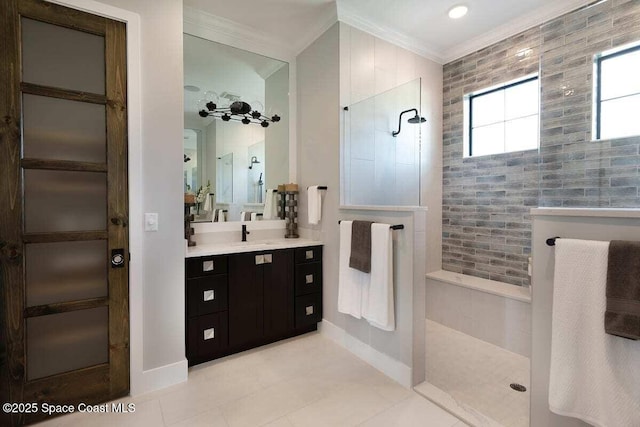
[443,0,592,64]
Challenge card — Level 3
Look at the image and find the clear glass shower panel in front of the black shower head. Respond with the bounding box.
[342,79,421,206]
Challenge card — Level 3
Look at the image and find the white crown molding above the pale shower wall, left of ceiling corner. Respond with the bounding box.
[337,2,444,64]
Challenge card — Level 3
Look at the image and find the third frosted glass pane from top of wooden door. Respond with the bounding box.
[24,169,107,233]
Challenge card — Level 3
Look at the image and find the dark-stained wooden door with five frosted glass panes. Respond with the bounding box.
[0,0,129,425]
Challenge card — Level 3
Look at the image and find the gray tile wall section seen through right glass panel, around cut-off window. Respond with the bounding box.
[540,0,640,208]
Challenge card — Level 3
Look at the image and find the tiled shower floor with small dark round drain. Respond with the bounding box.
[426,320,530,427]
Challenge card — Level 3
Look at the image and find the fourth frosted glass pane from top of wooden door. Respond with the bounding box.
[25,240,108,307]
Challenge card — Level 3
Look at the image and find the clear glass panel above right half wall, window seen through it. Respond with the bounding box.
[539,2,640,208]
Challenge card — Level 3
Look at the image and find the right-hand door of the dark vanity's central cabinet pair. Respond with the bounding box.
[263,250,294,338]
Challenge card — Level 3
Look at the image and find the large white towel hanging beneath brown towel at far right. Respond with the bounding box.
[549,239,640,427]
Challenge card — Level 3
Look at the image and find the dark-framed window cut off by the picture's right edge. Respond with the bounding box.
[594,46,640,139]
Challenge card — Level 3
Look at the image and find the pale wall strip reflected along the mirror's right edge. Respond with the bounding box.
[264,66,291,189]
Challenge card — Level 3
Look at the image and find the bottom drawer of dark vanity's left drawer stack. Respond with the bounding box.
[187,311,228,359]
